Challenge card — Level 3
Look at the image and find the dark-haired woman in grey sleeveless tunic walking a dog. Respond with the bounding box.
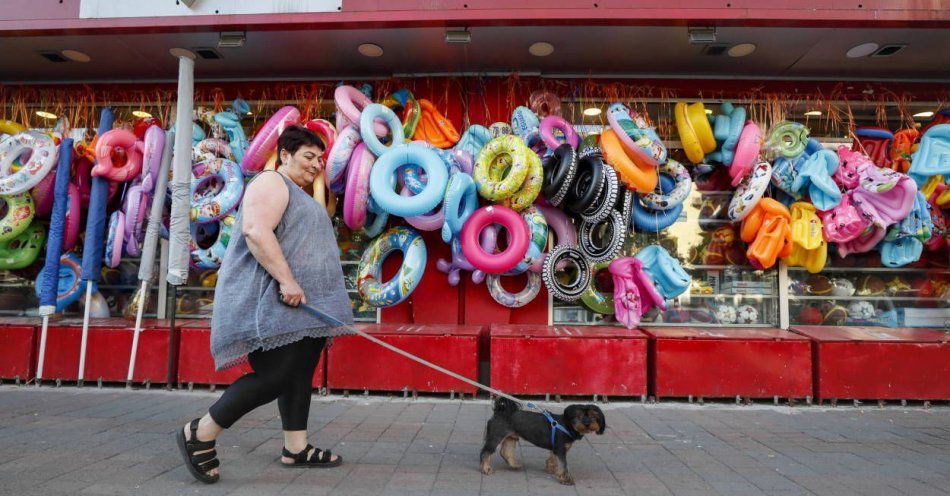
[176,126,353,484]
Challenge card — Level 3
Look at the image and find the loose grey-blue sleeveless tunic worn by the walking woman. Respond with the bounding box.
[211,172,353,370]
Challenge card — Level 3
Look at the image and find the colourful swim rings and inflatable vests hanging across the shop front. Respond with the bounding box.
[0,82,936,328]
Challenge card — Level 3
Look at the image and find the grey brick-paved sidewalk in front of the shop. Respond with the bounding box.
[0,386,950,496]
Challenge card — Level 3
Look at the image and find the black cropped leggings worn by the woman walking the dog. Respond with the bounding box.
[208,337,326,431]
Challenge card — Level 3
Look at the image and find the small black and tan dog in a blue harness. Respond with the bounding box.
[481,398,607,485]
